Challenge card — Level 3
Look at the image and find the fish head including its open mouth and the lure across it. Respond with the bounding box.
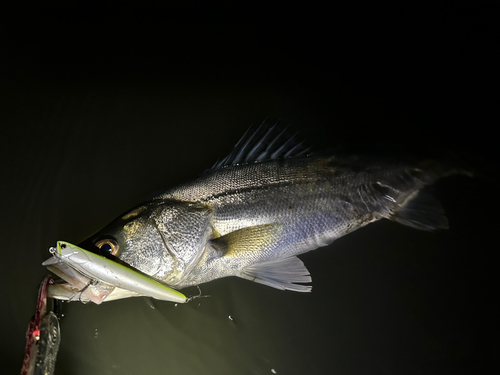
[43,201,197,303]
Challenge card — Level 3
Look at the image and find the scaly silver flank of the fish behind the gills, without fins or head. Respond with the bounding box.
[148,155,450,286]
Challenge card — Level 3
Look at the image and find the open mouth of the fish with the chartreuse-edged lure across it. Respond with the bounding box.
[42,241,188,304]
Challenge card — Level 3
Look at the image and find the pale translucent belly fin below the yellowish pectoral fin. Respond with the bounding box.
[237,256,312,292]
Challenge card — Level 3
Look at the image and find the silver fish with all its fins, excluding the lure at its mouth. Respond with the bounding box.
[46,123,469,299]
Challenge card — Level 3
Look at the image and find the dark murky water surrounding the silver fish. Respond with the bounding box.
[0,2,498,375]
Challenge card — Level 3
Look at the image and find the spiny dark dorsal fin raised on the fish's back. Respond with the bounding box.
[212,121,310,169]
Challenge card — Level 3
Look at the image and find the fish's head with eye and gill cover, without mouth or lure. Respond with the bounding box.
[79,199,212,286]
